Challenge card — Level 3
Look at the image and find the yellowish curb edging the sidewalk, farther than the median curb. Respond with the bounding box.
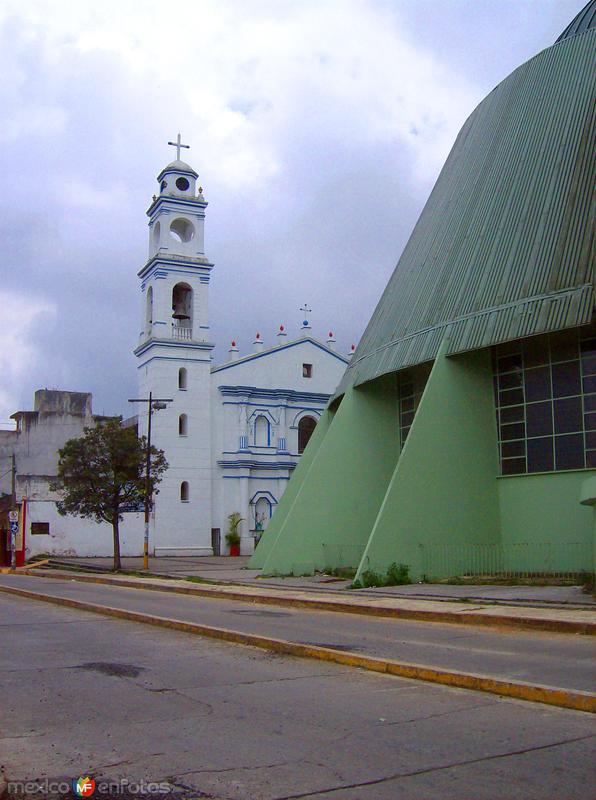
[16,571,596,636]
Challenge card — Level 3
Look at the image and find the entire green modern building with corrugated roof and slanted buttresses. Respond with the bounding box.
[250,0,596,579]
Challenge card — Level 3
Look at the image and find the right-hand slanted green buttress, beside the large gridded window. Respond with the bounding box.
[358,340,499,579]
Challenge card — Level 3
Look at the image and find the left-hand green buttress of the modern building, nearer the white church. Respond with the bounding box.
[263,375,399,574]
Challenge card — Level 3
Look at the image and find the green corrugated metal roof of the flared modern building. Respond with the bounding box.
[337,29,596,394]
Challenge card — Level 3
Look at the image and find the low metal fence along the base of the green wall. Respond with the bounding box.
[420,542,592,578]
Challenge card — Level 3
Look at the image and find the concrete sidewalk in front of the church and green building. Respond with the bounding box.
[44,556,596,611]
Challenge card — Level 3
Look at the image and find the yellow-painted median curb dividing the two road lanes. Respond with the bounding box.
[0,586,596,713]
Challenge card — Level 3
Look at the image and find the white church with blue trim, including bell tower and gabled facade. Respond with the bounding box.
[134,152,349,555]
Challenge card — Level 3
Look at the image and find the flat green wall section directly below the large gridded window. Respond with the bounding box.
[497,470,596,572]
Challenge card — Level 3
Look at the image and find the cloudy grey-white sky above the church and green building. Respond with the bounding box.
[0,0,583,421]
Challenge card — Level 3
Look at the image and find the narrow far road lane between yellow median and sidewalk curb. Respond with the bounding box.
[0,575,596,691]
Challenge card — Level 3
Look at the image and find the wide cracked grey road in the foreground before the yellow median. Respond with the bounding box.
[0,592,596,800]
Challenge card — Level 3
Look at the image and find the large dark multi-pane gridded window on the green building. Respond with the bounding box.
[494,326,596,475]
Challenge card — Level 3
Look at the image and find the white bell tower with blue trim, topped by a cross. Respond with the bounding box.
[134,134,213,556]
